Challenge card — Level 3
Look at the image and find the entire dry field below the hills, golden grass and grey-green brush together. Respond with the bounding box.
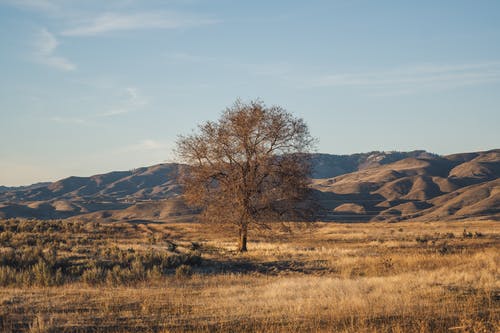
[0,220,500,332]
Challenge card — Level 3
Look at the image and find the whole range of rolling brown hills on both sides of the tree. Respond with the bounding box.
[0,149,500,221]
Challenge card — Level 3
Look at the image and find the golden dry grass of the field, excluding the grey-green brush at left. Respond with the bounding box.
[0,221,500,332]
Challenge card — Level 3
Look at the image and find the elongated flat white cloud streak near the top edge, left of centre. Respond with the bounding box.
[62,12,218,36]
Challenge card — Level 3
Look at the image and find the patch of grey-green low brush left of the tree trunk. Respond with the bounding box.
[0,219,201,286]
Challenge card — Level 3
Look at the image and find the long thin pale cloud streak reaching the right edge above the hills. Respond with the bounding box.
[309,62,500,96]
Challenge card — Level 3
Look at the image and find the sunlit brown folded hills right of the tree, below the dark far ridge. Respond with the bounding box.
[313,149,500,221]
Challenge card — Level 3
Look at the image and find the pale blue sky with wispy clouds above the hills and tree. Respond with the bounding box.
[0,0,500,185]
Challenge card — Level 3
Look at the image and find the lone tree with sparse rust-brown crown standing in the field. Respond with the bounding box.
[176,100,314,252]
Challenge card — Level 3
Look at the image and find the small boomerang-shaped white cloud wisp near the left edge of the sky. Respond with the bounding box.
[34,29,76,71]
